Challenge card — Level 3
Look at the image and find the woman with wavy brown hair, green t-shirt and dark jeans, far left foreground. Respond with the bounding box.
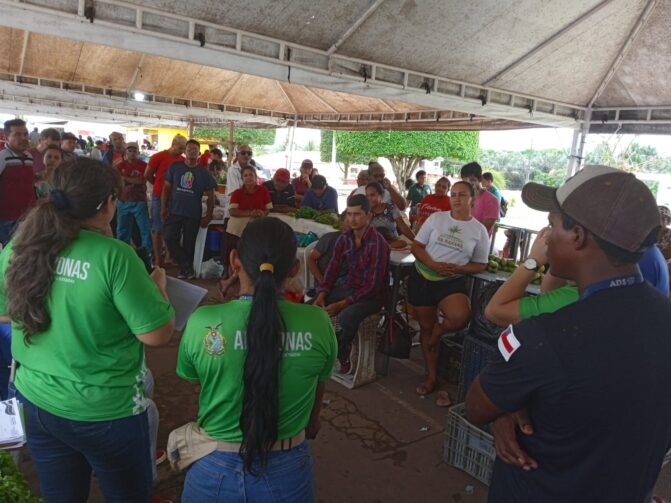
[0,157,174,503]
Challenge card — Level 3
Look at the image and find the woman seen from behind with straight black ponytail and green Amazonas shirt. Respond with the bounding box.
[177,217,337,503]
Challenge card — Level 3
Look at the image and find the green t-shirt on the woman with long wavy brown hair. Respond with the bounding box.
[0,230,174,421]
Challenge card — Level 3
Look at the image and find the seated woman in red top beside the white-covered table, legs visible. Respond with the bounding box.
[219,166,273,296]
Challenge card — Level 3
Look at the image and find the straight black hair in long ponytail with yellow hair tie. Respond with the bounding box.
[238,217,296,473]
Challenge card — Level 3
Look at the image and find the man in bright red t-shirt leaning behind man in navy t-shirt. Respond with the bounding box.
[144,134,186,265]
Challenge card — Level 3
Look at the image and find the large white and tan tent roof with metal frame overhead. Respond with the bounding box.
[0,0,671,132]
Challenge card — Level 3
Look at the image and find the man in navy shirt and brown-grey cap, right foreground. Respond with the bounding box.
[466,166,671,503]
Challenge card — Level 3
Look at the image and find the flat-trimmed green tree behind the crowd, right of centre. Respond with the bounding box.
[321,131,479,187]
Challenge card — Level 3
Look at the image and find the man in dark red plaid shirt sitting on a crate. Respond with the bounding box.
[315,194,389,374]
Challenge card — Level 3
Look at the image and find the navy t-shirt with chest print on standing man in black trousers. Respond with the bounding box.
[165,162,217,218]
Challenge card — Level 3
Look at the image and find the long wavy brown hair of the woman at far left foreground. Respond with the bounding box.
[5,157,121,344]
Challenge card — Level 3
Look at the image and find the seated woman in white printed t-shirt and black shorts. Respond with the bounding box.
[408,182,489,406]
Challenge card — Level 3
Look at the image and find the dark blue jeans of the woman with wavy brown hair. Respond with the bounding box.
[17,392,154,503]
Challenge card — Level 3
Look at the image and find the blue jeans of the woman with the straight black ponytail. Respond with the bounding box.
[181,442,314,503]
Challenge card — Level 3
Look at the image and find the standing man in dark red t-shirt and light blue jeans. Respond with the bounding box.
[116,142,152,253]
